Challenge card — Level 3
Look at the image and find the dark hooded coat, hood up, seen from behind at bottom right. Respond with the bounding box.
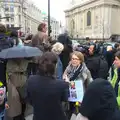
[80,79,120,120]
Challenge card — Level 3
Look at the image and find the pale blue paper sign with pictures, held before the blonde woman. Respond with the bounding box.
[68,80,84,102]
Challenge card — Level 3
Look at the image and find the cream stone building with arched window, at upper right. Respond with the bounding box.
[65,0,120,38]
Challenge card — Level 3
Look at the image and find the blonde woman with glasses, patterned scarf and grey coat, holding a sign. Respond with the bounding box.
[63,51,92,119]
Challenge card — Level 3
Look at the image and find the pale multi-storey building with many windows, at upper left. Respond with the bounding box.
[0,0,42,34]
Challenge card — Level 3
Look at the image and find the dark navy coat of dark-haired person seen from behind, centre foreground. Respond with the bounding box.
[26,75,69,120]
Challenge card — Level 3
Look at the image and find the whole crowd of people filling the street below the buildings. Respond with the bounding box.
[0,23,120,120]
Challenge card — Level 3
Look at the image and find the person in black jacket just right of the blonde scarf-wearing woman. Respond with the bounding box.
[86,44,108,79]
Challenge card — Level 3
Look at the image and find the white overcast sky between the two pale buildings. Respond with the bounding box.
[32,0,71,25]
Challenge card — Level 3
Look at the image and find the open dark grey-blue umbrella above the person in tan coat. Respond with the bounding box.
[0,46,43,59]
